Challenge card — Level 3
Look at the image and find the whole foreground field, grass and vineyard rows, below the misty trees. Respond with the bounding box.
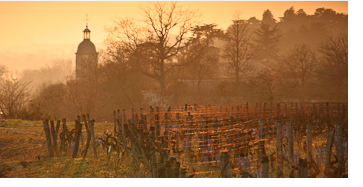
[0,104,348,178]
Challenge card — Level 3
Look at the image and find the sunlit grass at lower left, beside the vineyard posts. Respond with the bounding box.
[0,120,148,178]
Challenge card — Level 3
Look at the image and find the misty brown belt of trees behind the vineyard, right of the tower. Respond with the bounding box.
[3,2,348,119]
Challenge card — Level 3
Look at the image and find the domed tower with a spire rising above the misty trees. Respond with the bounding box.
[76,24,98,80]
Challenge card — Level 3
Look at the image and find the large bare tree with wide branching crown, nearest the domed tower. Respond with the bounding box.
[109,2,195,94]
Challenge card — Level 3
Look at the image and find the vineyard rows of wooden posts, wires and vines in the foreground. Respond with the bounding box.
[0,103,348,178]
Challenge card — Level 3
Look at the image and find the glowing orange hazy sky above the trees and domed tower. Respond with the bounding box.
[0,1,348,71]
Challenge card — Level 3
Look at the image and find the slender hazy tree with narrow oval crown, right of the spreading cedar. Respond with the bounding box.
[224,15,252,82]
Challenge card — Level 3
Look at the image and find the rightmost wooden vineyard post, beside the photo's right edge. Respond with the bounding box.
[335,122,345,178]
